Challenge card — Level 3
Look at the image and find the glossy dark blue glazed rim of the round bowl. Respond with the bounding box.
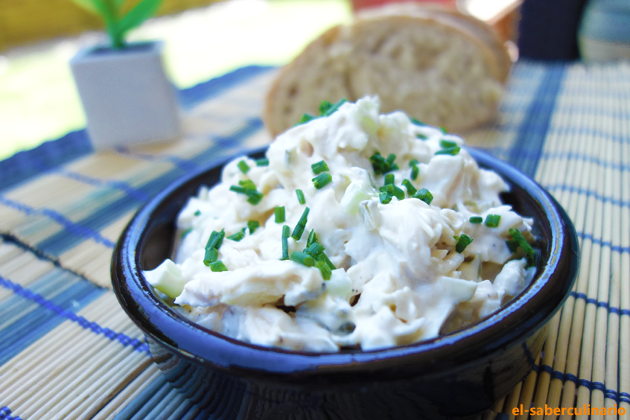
[111,146,579,376]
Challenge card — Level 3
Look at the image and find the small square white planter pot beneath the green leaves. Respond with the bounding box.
[70,42,180,149]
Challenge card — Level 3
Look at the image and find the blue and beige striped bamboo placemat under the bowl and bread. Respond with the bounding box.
[0,62,630,420]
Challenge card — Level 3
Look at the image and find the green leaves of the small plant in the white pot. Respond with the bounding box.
[72,0,162,49]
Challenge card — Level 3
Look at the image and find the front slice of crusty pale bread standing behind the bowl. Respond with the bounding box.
[264,10,509,137]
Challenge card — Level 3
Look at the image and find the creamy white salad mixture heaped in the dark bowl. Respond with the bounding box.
[144,97,535,352]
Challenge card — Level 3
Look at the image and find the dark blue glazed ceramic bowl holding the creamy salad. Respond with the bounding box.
[112,149,578,420]
